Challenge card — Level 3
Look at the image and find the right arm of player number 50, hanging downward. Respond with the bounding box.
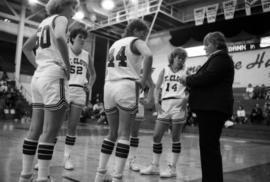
[54,16,70,79]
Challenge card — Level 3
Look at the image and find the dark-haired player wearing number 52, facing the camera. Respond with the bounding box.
[64,28,96,170]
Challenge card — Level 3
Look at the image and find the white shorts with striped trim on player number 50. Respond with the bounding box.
[31,76,69,110]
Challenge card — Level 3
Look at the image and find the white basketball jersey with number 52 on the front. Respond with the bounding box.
[69,47,89,86]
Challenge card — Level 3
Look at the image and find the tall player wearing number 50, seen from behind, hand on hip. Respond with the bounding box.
[19,0,79,182]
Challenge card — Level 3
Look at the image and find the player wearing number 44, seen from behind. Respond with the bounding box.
[95,19,153,182]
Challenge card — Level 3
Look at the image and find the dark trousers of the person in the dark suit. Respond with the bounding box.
[196,111,228,182]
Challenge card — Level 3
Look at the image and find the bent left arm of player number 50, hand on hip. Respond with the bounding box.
[23,33,38,68]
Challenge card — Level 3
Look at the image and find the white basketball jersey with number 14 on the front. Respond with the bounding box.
[161,66,186,99]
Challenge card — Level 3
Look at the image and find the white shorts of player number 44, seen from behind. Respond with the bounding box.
[104,79,138,113]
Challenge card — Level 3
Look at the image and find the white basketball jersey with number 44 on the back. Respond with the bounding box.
[105,37,142,81]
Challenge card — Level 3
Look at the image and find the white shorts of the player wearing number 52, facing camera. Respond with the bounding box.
[69,85,86,107]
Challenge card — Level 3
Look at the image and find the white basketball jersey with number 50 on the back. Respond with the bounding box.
[35,15,65,77]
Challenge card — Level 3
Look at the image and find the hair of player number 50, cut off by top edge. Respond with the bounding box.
[46,0,80,15]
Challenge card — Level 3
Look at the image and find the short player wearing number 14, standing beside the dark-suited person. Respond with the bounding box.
[140,48,187,178]
